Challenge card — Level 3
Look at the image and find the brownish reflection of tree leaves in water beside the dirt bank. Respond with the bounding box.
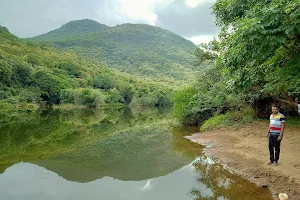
[191,158,273,200]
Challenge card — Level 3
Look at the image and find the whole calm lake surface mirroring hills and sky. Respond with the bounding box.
[0,109,272,200]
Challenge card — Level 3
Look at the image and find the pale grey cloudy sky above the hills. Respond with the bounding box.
[0,0,219,44]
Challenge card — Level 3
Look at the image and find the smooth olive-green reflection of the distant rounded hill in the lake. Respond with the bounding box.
[34,123,191,182]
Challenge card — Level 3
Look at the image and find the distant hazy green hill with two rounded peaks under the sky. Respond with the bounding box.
[30,20,201,82]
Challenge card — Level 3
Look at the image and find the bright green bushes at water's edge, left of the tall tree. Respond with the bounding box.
[173,60,240,124]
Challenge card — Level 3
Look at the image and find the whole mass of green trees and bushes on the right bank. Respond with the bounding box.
[174,0,300,123]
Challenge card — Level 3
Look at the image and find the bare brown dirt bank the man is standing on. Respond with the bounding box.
[186,121,300,200]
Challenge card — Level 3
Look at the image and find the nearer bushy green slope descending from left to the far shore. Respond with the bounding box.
[0,26,171,108]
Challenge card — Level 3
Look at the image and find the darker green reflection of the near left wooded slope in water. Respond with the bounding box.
[0,109,173,172]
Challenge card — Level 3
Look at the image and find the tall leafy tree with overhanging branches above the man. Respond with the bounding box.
[212,0,300,107]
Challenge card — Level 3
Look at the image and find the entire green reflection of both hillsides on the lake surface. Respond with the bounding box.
[0,109,195,182]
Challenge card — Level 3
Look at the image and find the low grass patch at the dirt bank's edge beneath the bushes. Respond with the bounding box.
[200,108,255,131]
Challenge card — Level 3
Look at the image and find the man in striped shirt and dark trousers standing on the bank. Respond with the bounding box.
[268,104,285,166]
